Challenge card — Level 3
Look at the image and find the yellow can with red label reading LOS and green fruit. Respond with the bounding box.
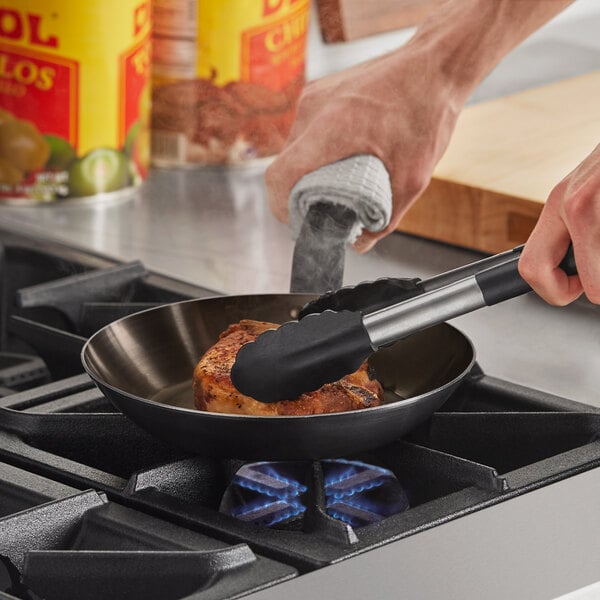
[0,0,152,203]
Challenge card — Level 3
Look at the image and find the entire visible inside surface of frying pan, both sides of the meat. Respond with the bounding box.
[83,294,473,409]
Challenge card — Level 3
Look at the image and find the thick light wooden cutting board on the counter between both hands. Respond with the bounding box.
[398,71,600,253]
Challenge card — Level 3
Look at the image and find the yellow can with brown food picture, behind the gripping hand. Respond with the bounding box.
[151,0,309,166]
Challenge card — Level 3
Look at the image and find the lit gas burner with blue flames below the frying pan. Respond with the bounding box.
[221,459,409,528]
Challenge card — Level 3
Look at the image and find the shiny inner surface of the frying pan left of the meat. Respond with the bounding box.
[82,294,314,409]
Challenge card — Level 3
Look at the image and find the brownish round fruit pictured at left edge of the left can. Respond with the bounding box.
[0,120,50,172]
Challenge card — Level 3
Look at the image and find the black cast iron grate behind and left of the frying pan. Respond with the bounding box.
[0,239,214,390]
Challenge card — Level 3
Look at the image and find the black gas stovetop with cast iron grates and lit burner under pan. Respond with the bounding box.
[0,233,600,600]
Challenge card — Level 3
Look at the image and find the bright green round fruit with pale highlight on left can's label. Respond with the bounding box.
[69,148,130,197]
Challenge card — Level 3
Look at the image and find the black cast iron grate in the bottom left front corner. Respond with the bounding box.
[0,463,296,600]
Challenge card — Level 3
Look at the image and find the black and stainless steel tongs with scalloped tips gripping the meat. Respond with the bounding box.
[231,246,577,402]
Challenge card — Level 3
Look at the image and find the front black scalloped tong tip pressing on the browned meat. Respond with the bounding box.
[231,311,373,402]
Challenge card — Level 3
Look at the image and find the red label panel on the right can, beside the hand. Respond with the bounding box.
[242,6,308,90]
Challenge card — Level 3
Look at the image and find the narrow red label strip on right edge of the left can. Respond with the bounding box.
[119,37,151,145]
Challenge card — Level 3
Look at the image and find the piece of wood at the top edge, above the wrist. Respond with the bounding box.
[317,0,444,42]
